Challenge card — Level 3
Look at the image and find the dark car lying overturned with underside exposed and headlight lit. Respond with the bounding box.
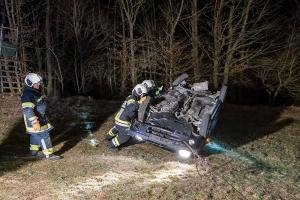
[130,74,227,158]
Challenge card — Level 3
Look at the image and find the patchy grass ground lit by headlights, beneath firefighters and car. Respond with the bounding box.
[0,96,300,200]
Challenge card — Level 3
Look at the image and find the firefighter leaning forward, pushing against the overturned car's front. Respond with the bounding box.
[106,84,148,149]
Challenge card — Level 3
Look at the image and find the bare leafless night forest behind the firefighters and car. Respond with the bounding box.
[3,0,300,103]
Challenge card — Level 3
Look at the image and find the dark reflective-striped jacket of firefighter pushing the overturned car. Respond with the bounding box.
[115,95,139,127]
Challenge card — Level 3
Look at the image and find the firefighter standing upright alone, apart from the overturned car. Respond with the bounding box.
[21,73,61,160]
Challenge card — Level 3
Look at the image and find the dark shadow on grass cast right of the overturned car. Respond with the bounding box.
[213,105,294,148]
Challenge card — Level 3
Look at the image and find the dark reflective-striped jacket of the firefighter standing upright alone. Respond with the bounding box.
[21,86,53,134]
